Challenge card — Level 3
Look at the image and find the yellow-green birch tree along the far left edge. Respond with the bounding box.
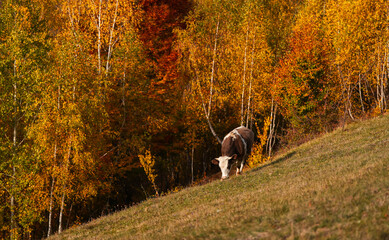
[0,1,47,239]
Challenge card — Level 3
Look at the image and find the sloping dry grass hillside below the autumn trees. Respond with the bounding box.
[53,116,389,239]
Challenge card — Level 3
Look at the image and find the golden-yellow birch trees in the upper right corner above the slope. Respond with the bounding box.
[325,1,387,118]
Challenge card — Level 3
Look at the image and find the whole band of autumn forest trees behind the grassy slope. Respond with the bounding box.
[0,0,389,239]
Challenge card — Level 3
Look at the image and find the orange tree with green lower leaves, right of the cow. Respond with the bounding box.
[276,6,337,137]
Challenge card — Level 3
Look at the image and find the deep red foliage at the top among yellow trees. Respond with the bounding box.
[139,0,191,98]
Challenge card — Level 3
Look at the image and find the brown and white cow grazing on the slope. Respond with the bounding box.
[212,126,254,180]
